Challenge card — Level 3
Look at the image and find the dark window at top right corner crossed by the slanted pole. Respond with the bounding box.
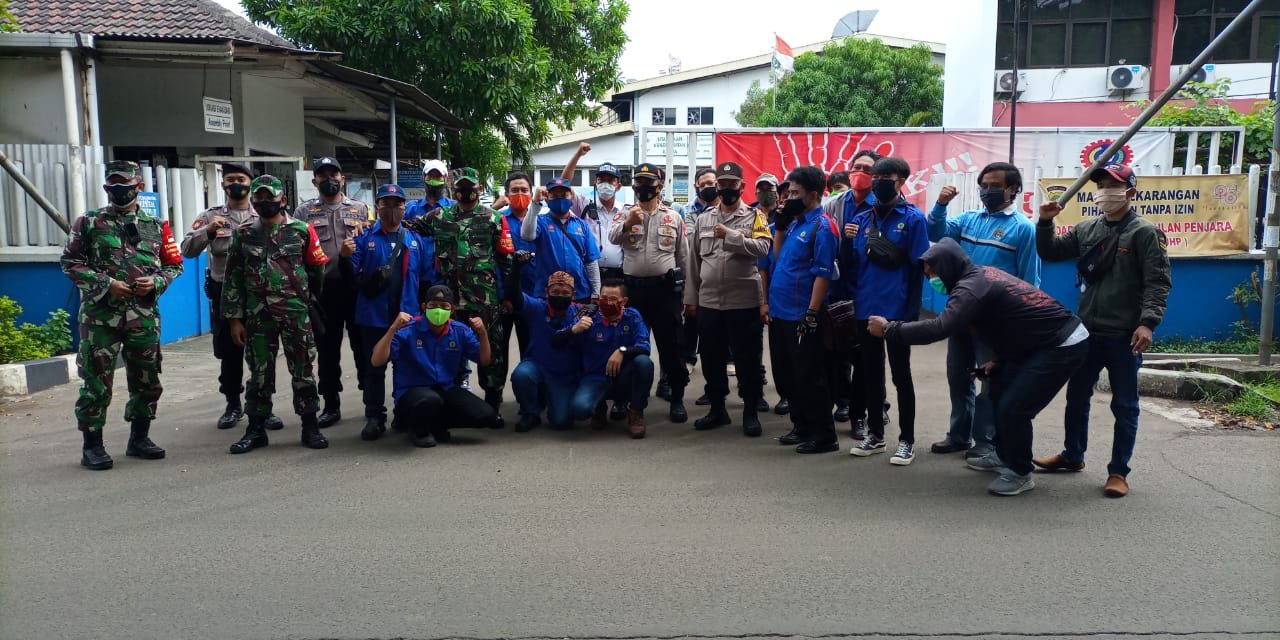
[1174,0,1280,64]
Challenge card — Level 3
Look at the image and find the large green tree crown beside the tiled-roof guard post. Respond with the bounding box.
[243,0,630,172]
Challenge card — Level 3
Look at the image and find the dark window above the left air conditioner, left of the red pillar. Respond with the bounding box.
[996,0,1155,69]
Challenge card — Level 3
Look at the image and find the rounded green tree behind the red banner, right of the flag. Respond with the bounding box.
[735,37,942,127]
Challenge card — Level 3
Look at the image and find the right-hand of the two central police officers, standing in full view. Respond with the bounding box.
[685,163,773,438]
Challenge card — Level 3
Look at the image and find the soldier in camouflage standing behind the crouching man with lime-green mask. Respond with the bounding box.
[406,166,516,424]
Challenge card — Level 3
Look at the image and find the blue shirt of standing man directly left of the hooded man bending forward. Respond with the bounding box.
[852,198,929,320]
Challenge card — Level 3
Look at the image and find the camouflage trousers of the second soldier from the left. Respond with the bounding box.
[244,311,320,417]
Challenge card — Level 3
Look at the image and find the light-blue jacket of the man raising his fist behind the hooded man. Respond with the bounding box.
[929,201,1041,287]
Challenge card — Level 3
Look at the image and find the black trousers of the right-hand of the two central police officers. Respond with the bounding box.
[690,307,764,407]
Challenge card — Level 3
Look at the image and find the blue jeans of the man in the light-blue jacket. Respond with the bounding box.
[947,333,996,448]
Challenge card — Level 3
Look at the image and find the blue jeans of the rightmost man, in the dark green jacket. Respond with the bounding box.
[1062,335,1142,476]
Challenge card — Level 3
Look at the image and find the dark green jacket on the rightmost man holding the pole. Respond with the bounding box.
[1036,211,1172,335]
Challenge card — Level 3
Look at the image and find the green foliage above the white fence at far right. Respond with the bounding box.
[1129,78,1276,165]
